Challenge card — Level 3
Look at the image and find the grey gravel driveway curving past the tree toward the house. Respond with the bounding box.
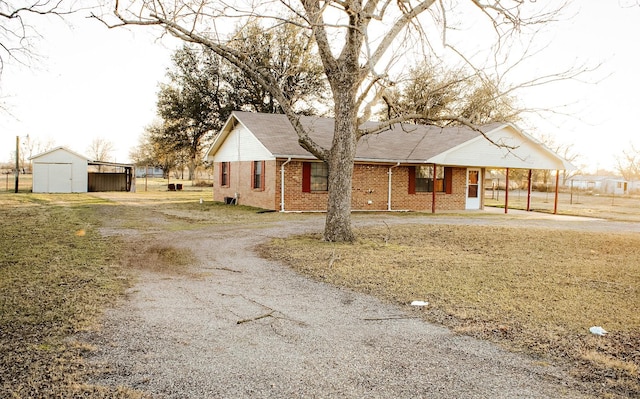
[84,205,640,398]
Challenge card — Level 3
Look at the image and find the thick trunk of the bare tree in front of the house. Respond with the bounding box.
[324,101,357,242]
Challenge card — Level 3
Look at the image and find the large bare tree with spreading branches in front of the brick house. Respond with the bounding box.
[96,0,584,241]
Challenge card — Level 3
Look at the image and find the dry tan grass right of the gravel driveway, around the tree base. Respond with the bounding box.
[261,225,640,397]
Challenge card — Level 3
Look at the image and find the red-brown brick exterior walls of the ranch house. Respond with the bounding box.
[213,160,484,211]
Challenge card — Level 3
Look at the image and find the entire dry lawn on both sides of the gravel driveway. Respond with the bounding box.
[0,185,640,398]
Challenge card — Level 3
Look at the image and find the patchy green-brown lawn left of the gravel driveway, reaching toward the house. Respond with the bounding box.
[0,190,293,398]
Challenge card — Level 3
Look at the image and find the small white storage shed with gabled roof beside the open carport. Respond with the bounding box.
[31,147,89,193]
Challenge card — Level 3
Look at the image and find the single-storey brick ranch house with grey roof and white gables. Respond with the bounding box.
[205,111,571,212]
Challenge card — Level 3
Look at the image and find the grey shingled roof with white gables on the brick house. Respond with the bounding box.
[207,111,575,169]
